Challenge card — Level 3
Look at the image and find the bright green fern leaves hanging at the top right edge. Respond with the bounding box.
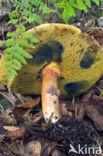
[52,0,103,24]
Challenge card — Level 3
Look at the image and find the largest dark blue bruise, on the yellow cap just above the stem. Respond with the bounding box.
[28,41,64,65]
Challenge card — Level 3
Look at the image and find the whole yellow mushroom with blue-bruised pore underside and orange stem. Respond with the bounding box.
[0,23,103,123]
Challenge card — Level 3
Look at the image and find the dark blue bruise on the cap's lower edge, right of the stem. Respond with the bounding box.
[64,80,89,96]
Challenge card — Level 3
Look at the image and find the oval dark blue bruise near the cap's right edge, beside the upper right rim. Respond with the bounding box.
[80,52,96,69]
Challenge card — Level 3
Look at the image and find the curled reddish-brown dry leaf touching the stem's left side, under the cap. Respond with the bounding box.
[13,97,40,119]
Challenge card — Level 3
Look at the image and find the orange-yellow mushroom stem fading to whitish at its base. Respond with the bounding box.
[42,62,61,123]
